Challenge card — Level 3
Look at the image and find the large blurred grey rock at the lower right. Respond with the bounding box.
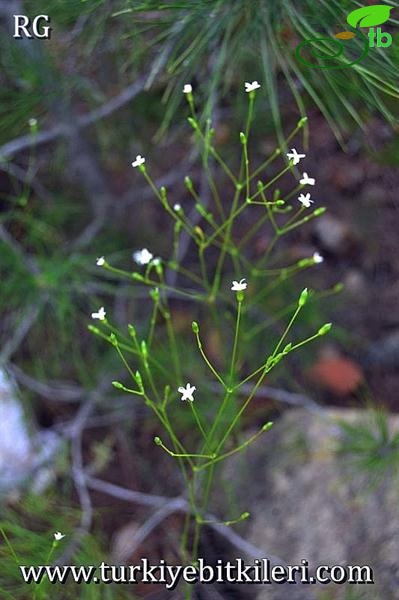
[226,409,399,600]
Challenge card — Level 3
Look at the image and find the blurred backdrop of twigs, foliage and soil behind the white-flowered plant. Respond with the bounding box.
[0,0,399,600]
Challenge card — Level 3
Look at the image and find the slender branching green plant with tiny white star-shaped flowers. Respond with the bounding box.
[89,82,337,584]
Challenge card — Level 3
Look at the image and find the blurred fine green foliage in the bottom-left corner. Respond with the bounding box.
[0,495,134,600]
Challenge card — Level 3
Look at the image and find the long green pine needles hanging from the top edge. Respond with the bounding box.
[114,0,399,138]
